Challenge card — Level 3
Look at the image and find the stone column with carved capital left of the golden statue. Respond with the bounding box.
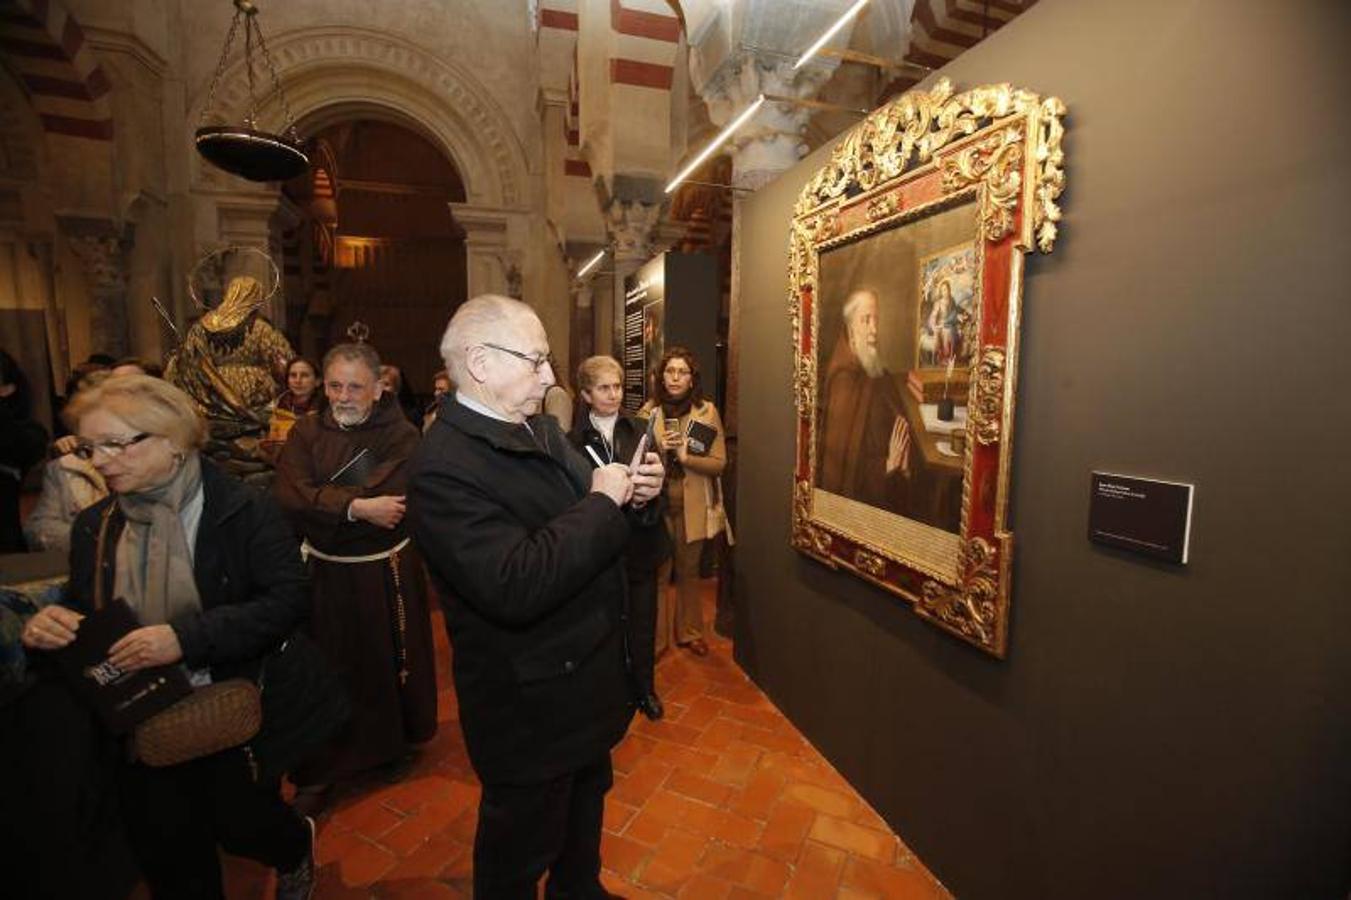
[57,216,131,357]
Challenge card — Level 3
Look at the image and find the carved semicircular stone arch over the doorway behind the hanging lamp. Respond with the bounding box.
[189,27,530,207]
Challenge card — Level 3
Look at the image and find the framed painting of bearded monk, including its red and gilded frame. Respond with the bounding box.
[790,78,1065,657]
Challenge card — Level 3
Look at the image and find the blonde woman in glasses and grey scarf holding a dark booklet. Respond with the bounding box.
[23,374,313,900]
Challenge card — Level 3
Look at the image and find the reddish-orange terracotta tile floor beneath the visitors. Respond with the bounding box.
[208,586,950,900]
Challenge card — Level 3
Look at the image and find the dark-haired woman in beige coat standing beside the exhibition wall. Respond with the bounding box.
[643,346,727,657]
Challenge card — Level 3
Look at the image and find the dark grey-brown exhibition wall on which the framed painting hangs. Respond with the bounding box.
[736,0,1351,900]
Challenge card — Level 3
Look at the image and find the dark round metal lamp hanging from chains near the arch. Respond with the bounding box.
[196,0,309,181]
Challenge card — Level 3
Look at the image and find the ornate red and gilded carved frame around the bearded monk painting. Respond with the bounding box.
[789,78,1065,658]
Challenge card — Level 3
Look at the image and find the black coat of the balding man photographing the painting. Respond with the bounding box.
[408,397,659,784]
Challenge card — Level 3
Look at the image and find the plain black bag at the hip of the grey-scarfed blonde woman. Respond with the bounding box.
[249,631,351,780]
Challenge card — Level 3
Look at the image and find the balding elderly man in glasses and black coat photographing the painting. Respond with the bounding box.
[408,295,663,900]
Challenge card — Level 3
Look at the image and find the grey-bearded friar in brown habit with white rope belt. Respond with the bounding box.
[273,343,436,808]
